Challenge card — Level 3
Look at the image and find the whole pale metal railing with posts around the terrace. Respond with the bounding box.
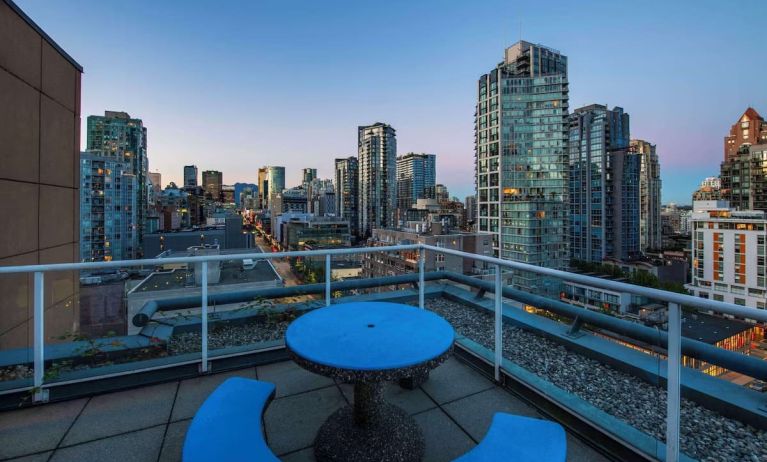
[0,244,767,461]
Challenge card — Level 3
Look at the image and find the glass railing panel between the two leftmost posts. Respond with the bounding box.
[35,266,200,385]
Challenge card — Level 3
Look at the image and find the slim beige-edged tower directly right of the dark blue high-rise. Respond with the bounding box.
[631,140,663,252]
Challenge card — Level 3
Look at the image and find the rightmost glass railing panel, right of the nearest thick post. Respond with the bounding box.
[680,307,767,461]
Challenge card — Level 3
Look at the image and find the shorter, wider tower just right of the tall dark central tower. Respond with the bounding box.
[397,152,437,220]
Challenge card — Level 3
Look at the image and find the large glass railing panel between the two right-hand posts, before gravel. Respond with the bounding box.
[503,271,666,457]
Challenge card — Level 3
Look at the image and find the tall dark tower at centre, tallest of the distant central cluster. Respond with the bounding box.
[357,122,397,238]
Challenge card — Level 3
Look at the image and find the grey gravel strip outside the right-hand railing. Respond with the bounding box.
[426,298,767,462]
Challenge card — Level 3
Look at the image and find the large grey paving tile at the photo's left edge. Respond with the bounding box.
[0,399,88,459]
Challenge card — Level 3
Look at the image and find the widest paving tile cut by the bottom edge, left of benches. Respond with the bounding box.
[51,425,165,462]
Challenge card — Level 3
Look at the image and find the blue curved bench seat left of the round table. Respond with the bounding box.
[182,377,279,462]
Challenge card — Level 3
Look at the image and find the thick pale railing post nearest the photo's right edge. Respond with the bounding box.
[666,303,682,462]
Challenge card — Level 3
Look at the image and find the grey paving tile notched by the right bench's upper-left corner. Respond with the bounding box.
[443,388,541,441]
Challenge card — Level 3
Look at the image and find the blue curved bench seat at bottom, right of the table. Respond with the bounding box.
[455,412,567,462]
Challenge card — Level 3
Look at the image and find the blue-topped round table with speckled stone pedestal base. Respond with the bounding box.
[285,302,455,461]
